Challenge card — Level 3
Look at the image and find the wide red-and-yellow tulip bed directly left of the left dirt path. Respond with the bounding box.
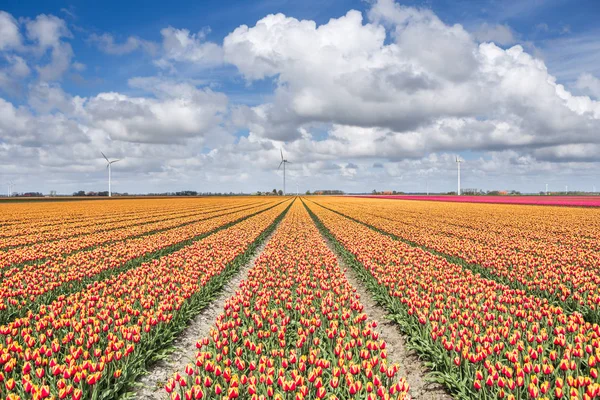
[0,201,289,400]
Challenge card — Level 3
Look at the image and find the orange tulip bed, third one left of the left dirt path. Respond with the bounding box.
[0,200,265,272]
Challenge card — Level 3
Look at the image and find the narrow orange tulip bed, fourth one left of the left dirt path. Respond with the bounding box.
[0,202,247,250]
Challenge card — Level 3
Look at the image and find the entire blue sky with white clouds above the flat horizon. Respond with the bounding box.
[0,0,600,193]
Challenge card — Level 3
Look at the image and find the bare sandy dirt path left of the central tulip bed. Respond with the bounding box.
[132,229,277,400]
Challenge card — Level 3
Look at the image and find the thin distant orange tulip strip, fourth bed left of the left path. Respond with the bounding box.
[0,202,258,252]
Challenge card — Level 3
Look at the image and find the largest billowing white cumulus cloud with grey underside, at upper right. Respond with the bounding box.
[223,0,600,164]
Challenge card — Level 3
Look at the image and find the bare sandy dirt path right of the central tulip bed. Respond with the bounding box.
[323,238,452,400]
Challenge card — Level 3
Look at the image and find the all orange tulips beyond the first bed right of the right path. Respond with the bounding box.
[319,199,600,322]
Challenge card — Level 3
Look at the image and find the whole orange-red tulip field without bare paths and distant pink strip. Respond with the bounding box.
[0,196,600,400]
